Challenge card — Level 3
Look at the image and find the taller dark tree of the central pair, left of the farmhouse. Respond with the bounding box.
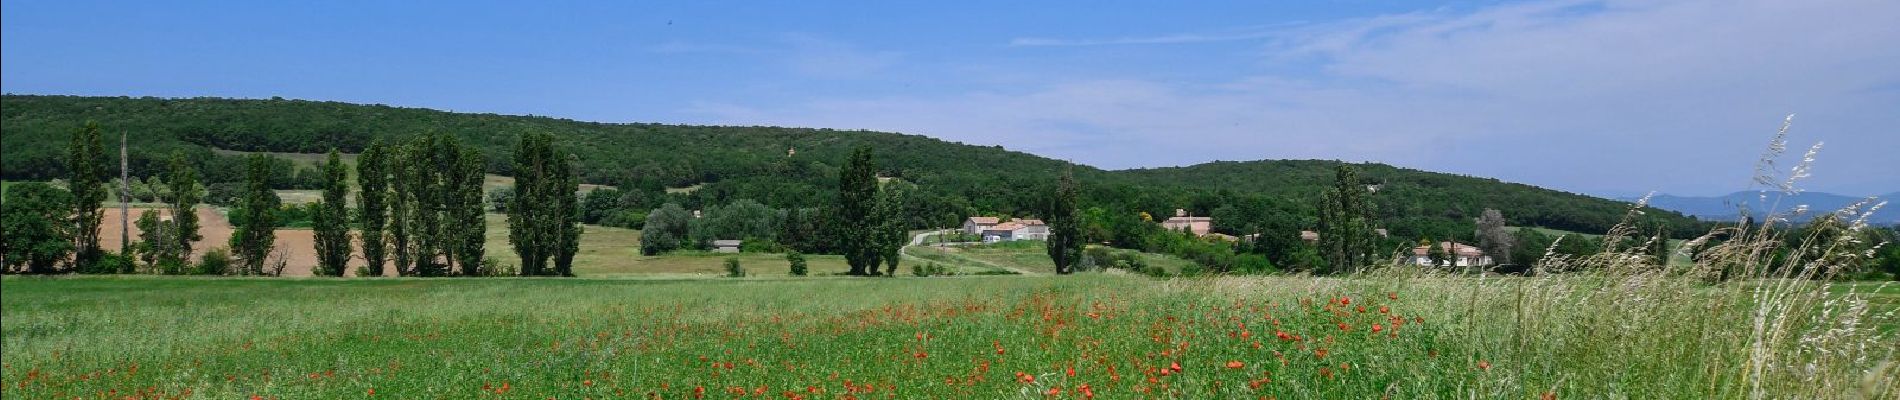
[836,146,880,275]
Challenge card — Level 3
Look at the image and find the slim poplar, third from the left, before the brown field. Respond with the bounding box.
[230,155,281,275]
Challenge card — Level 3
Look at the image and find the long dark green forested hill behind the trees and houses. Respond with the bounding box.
[0,95,1697,239]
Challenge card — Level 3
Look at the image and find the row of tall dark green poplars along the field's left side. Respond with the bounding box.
[0,121,581,277]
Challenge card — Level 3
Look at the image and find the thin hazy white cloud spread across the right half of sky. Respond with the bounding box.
[699,0,1900,193]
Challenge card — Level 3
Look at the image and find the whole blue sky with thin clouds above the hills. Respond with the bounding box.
[0,0,1900,195]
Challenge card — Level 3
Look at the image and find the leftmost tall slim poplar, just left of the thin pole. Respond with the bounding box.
[67,121,106,271]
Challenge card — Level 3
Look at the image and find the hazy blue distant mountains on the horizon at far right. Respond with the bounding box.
[1623,191,1900,224]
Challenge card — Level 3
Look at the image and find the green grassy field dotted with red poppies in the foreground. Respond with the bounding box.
[0,273,1900,398]
